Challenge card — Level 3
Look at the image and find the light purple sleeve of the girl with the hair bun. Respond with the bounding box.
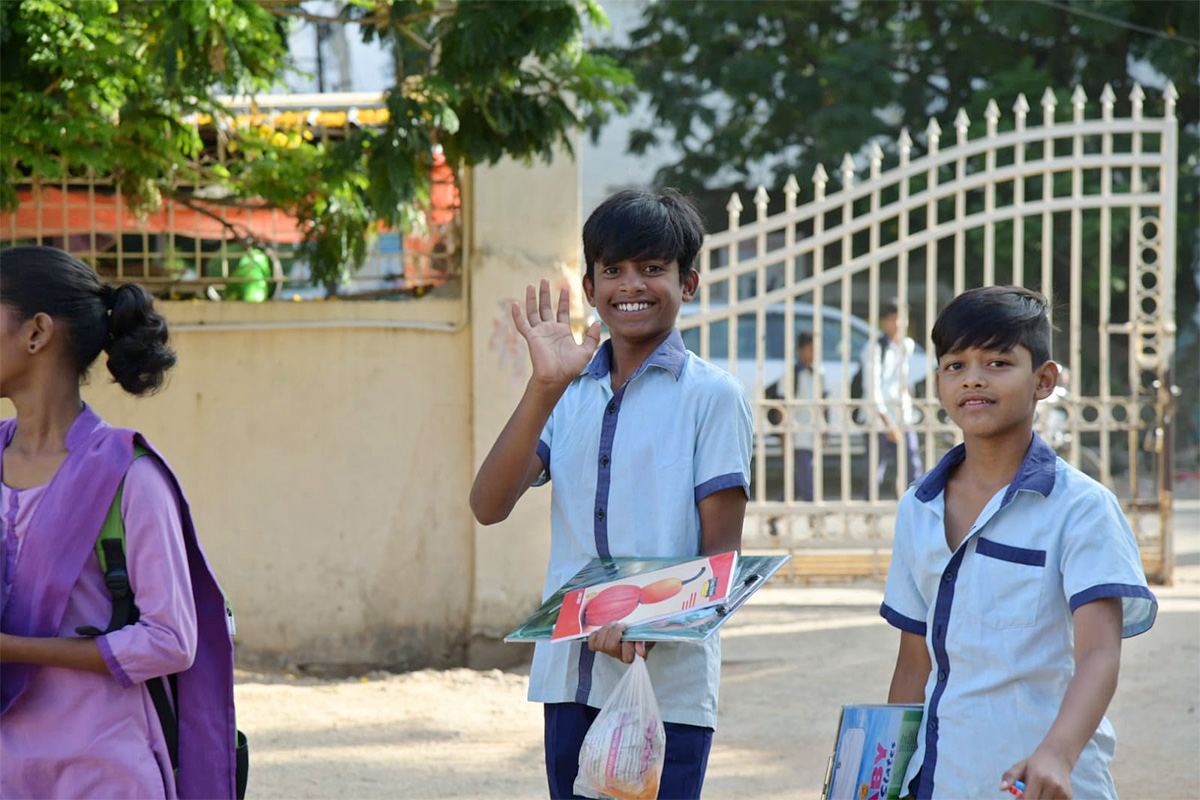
[96,456,197,687]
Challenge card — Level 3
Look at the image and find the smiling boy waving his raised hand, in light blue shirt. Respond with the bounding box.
[470,191,752,798]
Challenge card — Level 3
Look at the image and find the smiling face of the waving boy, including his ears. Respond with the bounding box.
[583,258,700,345]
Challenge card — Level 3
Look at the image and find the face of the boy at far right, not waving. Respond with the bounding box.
[935,345,1058,438]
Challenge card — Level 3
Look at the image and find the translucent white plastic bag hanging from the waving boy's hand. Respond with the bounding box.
[575,655,667,800]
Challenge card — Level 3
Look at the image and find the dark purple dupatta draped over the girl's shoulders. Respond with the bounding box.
[0,405,236,798]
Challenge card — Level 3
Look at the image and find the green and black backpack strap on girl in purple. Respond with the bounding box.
[76,444,179,770]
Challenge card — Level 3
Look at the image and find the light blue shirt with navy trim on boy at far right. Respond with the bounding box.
[880,434,1158,798]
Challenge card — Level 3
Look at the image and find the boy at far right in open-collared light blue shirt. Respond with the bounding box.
[880,287,1157,800]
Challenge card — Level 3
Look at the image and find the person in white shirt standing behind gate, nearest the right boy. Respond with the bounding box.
[862,299,924,494]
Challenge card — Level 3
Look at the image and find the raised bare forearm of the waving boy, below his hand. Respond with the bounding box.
[470,380,565,525]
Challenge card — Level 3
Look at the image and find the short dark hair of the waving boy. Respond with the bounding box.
[583,188,704,283]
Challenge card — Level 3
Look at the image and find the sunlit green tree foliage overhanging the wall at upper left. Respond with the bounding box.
[0,0,628,284]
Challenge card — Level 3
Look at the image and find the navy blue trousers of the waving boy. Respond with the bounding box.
[545,703,713,800]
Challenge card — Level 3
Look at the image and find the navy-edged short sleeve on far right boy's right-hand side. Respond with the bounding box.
[1060,486,1158,638]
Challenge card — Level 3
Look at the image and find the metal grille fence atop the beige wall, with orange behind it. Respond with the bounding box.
[0,94,462,300]
